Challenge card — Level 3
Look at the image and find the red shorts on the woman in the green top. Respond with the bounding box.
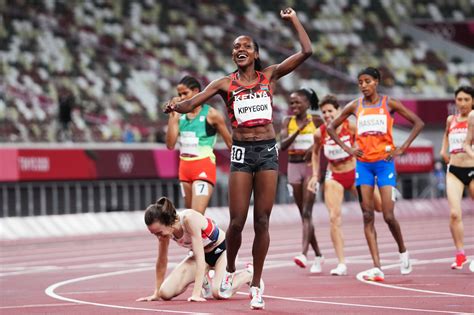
[179,157,216,185]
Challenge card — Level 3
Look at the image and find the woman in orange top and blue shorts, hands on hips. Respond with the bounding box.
[327,67,424,281]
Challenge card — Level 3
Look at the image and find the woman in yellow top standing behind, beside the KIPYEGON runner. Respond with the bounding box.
[280,88,324,273]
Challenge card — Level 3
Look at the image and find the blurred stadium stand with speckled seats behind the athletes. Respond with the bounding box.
[0,0,474,142]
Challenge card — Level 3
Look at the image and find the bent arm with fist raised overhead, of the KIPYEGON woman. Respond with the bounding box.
[264,8,313,81]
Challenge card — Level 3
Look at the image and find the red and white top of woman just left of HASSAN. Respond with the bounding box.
[319,120,354,164]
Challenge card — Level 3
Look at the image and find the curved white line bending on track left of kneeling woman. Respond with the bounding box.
[44,267,209,314]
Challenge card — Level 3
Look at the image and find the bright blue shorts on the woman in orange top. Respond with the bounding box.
[356,160,397,187]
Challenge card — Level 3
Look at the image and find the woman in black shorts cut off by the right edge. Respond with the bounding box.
[440,86,474,269]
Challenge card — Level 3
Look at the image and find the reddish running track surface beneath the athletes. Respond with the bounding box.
[0,215,474,314]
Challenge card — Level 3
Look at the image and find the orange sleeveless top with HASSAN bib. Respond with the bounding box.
[356,95,395,162]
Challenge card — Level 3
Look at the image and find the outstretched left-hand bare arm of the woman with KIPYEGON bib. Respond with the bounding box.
[163,77,229,113]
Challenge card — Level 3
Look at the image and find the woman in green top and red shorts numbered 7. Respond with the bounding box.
[166,76,232,214]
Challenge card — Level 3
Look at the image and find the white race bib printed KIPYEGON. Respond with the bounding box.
[234,91,272,125]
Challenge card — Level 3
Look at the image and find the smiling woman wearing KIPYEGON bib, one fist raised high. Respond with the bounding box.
[165,8,312,309]
